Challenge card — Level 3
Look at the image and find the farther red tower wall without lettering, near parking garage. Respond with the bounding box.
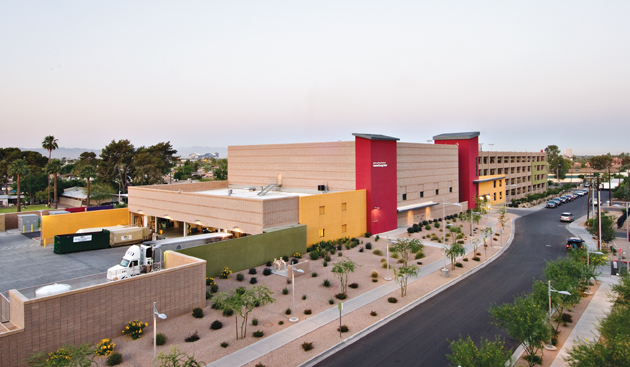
[435,137,479,208]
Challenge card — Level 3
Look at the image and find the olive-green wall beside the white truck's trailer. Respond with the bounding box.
[178,224,306,277]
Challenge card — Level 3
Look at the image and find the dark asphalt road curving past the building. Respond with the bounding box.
[317,197,586,367]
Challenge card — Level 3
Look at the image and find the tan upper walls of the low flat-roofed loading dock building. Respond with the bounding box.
[129,181,298,234]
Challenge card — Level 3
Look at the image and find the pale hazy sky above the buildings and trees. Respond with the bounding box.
[0,0,630,154]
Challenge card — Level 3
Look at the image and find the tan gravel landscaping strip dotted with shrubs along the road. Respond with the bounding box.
[97,216,514,366]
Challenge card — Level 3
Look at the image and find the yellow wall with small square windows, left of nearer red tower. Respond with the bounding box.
[299,190,366,246]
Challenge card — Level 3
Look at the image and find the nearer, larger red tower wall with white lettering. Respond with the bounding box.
[355,137,398,234]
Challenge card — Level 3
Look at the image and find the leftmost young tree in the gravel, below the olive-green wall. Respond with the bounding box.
[214,285,276,340]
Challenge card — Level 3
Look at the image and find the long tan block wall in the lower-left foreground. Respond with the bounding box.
[0,252,206,367]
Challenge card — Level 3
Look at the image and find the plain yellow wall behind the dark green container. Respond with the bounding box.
[42,208,130,245]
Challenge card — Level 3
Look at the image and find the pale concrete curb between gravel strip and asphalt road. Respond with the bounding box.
[298,219,515,367]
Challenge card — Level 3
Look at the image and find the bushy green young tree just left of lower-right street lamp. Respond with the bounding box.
[490,295,550,367]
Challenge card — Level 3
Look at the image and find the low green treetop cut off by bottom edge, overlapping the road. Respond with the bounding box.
[446,336,512,367]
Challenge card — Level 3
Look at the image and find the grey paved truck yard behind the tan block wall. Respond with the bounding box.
[0,230,129,292]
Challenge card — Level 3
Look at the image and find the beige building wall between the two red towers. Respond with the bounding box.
[397,142,459,208]
